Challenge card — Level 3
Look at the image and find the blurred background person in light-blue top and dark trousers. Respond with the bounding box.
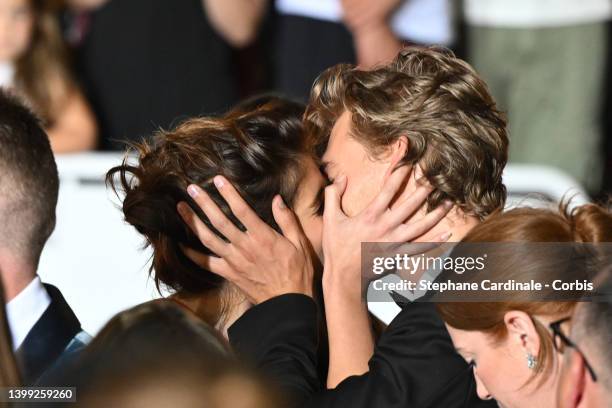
[274,0,453,100]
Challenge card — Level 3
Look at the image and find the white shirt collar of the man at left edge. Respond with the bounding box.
[6,276,51,350]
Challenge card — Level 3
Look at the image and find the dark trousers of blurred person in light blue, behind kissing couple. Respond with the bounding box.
[274,14,357,102]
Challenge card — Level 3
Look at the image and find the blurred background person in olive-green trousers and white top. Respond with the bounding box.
[464,0,612,192]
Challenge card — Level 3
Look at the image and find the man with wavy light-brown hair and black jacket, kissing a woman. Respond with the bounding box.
[179,47,508,407]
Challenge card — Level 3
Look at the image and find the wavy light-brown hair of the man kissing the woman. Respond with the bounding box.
[305,47,508,218]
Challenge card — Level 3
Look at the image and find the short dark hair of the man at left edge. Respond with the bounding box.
[0,90,59,262]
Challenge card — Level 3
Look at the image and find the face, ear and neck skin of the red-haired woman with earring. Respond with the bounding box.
[446,311,561,408]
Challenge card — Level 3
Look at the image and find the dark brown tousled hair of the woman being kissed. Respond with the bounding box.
[107,96,311,294]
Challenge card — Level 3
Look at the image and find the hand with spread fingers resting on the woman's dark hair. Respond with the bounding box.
[177,176,314,304]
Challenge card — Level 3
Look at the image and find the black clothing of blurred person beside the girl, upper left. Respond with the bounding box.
[78,0,237,149]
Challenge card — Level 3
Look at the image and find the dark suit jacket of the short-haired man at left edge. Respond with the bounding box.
[16,284,81,386]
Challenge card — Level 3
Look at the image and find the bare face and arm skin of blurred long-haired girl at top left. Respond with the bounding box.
[0,0,97,153]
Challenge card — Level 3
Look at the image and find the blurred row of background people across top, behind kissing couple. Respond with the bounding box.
[0,0,612,195]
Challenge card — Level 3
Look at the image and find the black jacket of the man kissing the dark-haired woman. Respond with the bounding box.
[228,294,497,408]
